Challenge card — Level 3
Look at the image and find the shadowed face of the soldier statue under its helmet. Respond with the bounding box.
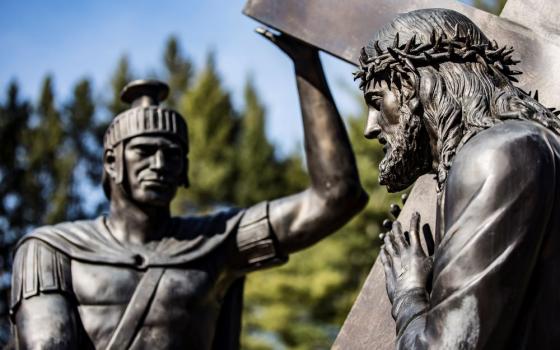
[124,135,185,206]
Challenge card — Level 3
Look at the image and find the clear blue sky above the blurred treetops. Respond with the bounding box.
[0,0,358,152]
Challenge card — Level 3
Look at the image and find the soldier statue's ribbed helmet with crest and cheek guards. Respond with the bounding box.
[102,80,189,198]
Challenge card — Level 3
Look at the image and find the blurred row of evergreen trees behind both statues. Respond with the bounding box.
[0,0,505,350]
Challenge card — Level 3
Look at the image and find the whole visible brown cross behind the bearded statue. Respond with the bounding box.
[244,0,560,350]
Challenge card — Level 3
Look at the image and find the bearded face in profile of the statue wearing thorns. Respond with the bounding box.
[364,82,430,192]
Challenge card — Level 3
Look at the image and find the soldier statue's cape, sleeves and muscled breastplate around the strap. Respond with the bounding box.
[11,202,280,349]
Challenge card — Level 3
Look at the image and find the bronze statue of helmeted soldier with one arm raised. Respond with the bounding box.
[11,30,367,349]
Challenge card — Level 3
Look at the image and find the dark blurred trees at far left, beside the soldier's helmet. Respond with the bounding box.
[0,76,98,344]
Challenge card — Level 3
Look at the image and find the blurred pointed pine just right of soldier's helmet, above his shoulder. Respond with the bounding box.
[174,55,239,213]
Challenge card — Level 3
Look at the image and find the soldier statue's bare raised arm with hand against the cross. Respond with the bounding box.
[257,28,368,254]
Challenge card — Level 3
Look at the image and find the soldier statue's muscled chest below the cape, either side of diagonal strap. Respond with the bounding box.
[72,259,228,348]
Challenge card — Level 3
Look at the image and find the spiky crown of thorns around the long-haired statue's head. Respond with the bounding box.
[354,26,522,91]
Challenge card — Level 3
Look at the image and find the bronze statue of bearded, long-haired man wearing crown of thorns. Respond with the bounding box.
[356,9,560,349]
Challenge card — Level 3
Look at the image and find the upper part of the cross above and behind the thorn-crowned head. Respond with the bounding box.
[244,0,560,107]
